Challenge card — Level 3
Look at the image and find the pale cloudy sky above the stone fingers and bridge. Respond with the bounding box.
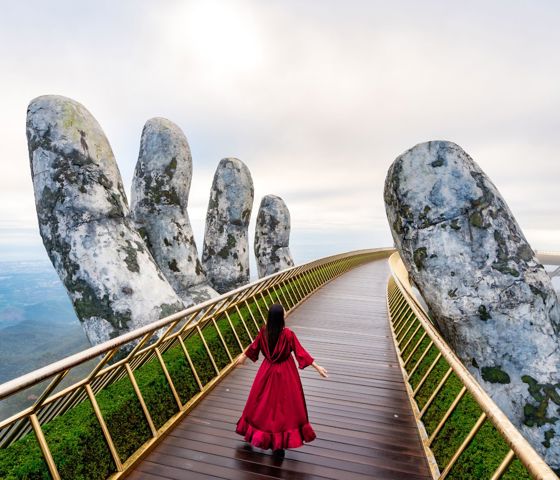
[0,0,560,263]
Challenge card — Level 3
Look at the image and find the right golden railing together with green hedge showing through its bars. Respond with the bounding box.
[387,253,558,480]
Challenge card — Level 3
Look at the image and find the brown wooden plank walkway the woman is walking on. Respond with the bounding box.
[129,260,431,480]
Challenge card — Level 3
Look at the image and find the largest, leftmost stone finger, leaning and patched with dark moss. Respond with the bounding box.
[27,96,183,344]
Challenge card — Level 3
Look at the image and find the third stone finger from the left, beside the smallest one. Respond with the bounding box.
[202,158,254,293]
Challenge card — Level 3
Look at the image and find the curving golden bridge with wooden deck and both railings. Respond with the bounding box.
[0,249,557,480]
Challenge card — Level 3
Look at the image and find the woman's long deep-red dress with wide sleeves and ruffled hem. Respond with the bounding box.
[235,328,315,450]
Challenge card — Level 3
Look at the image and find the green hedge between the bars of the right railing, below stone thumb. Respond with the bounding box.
[399,306,531,480]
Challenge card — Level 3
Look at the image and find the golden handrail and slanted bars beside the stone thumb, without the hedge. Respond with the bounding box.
[387,253,558,480]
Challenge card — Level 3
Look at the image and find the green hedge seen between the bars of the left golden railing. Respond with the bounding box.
[0,266,334,480]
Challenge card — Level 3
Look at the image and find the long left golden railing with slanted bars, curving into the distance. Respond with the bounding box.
[0,249,390,479]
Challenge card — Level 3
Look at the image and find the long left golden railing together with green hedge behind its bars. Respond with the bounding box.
[0,249,392,479]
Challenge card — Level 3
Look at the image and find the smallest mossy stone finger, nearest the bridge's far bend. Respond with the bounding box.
[255,195,294,278]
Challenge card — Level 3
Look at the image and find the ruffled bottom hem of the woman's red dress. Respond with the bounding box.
[235,416,316,450]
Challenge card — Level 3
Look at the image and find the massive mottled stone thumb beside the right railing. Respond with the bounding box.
[385,142,560,468]
